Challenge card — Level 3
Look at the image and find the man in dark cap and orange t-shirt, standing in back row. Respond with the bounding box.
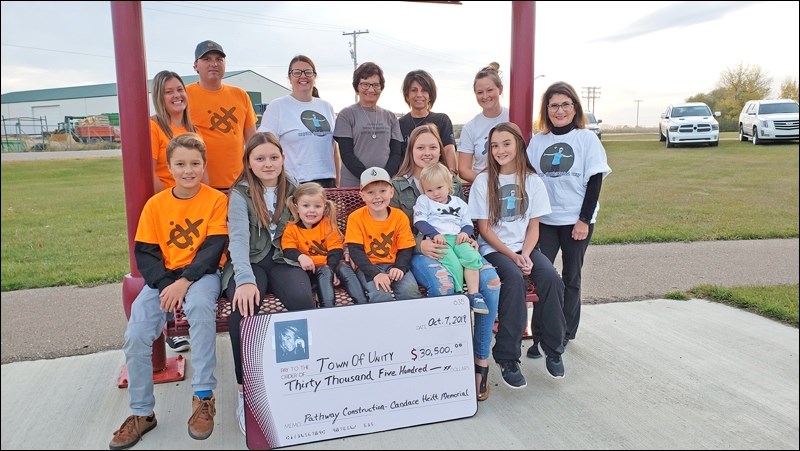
[186,41,256,190]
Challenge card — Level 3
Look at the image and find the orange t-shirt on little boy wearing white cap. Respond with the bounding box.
[344,207,417,265]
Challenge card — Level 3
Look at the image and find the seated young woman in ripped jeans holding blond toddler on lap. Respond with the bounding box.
[391,124,500,401]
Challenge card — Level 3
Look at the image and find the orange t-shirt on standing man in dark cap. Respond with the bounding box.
[186,82,256,189]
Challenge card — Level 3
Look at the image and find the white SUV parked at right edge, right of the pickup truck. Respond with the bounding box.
[739,99,800,145]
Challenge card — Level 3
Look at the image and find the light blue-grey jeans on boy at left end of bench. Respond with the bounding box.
[123,273,220,416]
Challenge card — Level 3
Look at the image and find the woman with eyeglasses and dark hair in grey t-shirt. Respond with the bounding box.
[333,63,403,188]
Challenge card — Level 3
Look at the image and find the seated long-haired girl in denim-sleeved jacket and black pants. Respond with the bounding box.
[222,132,314,434]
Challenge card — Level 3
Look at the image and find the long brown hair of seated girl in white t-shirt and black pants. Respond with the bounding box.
[486,122,536,225]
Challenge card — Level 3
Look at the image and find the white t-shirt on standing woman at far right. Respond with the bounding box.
[527,128,611,226]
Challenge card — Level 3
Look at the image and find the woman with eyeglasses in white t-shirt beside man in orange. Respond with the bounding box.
[258,55,339,188]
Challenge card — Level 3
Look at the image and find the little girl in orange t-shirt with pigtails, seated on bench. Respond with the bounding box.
[281,182,367,307]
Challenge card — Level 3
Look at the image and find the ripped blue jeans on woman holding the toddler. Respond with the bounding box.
[411,254,500,359]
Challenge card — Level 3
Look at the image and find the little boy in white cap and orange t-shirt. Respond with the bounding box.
[344,167,422,302]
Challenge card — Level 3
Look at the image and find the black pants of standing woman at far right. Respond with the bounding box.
[531,224,594,342]
